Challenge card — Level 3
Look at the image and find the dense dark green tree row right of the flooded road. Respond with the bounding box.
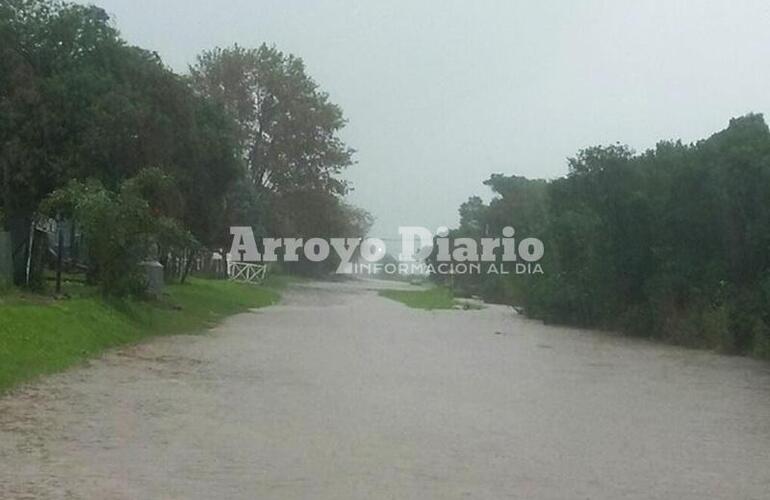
[440,114,770,357]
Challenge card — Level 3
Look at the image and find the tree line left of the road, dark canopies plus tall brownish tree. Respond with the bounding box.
[0,0,370,292]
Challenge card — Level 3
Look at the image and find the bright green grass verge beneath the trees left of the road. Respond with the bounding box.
[0,277,286,393]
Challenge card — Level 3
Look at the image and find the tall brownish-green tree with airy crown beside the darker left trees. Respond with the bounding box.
[190,44,364,252]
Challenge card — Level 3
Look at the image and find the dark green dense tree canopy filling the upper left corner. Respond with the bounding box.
[0,0,242,254]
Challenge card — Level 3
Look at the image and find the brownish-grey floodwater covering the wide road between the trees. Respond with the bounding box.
[0,283,770,500]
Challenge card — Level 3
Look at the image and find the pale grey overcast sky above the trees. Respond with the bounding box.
[84,0,770,240]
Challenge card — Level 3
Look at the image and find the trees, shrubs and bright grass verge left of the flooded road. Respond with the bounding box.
[0,0,371,391]
